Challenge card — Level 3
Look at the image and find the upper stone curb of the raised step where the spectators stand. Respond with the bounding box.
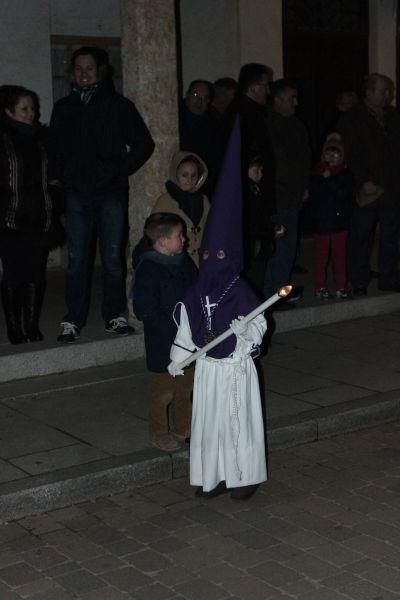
[0,294,400,382]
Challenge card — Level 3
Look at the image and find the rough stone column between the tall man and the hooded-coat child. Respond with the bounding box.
[121,0,178,244]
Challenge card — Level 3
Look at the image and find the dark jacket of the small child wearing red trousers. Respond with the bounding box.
[310,168,354,233]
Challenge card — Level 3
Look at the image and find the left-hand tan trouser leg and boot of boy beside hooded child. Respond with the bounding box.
[149,373,180,452]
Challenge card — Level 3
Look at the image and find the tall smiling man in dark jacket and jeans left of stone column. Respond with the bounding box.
[50,46,154,342]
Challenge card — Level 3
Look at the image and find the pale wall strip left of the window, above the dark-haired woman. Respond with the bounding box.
[0,0,52,122]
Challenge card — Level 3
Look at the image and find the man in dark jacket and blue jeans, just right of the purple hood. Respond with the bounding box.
[264,79,311,306]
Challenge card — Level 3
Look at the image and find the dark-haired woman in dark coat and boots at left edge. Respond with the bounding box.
[0,85,59,344]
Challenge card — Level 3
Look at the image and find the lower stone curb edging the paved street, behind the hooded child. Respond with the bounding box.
[0,390,400,522]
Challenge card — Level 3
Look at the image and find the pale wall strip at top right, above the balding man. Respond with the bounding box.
[369,0,397,82]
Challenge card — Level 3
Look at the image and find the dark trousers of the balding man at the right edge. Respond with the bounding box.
[348,202,400,287]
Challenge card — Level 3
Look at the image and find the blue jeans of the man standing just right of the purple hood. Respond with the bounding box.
[263,208,300,298]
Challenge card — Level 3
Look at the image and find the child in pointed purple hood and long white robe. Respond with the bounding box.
[168,120,267,500]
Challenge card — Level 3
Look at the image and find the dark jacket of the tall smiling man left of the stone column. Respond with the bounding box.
[49,83,154,193]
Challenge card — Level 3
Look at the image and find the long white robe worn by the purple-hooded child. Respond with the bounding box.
[171,304,268,492]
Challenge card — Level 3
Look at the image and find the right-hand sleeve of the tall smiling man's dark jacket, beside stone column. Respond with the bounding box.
[122,98,155,175]
